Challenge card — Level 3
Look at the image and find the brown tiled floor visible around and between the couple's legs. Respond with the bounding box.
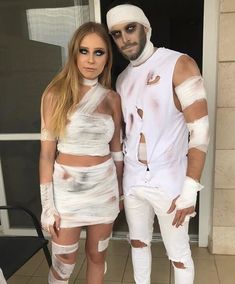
[7,240,235,284]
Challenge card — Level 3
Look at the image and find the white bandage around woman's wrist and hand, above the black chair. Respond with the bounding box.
[40,182,59,228]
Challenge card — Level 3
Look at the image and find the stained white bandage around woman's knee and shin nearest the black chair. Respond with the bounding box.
[52,242,78,279]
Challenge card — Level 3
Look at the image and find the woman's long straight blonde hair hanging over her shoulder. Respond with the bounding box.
[43,22,112,137]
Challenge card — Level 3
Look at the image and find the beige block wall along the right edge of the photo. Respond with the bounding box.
[211,0,235,254]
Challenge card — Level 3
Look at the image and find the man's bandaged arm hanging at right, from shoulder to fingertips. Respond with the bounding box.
[167,55,209,227]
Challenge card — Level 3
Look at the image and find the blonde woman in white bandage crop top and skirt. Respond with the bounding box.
[40,22,123,284]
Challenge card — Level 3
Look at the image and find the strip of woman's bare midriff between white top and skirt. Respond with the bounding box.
[56,153,111,167]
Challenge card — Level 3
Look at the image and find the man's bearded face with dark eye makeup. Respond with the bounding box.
[110,22,146,60]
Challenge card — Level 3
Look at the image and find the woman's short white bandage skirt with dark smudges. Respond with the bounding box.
[53,159,119,228]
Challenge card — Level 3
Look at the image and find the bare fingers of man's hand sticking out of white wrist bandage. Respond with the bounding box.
[167,196,195,228]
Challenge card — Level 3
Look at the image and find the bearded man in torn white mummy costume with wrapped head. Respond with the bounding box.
[107,4,209,284]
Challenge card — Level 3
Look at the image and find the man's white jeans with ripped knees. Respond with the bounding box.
[124,186,194,284]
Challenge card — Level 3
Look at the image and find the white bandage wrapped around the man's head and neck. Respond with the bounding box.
[106,4,154,66]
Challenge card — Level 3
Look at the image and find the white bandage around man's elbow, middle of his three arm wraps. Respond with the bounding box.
[187,115,210,153]
